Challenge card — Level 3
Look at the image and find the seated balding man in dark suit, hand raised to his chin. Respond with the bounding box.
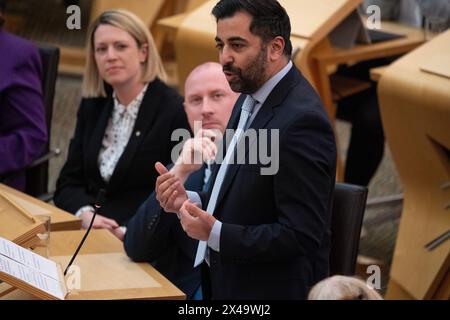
[124,63,238,299]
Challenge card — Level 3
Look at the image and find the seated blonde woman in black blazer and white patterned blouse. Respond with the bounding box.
[54,10,189,239]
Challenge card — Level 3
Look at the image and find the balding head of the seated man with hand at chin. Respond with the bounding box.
[184,62,239,133]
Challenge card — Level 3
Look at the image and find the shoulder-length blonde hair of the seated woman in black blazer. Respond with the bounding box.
[82,9,167,98]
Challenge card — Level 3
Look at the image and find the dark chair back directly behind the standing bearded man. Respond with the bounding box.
[330,183,368,276]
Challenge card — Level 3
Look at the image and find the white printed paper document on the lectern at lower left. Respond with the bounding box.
[0,237,65,299]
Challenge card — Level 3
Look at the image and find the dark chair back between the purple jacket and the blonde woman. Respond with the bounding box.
[25,47,59,197]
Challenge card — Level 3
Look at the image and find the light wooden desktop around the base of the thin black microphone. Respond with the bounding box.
[0,230,186,300]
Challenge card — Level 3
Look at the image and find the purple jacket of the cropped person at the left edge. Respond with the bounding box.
[0,30,47,190]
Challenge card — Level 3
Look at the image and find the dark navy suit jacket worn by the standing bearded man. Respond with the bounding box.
[201,67,336,299]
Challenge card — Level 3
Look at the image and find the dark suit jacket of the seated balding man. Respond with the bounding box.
[124,169,205,299]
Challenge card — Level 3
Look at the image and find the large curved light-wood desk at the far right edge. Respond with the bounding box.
[378,30,450,299]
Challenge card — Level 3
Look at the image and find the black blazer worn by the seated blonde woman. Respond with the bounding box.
[54,79,189,225]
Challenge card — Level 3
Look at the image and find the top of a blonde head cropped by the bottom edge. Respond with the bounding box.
[308,276,383,300]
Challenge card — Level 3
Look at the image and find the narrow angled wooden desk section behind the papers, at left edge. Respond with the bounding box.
[0,183,81,231]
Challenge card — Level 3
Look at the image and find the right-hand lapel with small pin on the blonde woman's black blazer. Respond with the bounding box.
[109,79,162,188]
